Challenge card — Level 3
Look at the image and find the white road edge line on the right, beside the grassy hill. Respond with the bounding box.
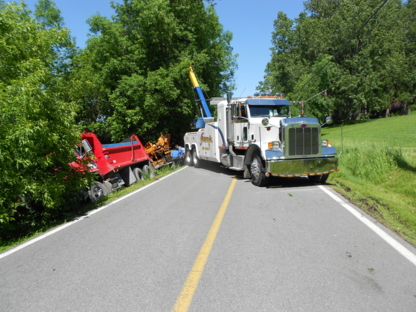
[318,185,416,265]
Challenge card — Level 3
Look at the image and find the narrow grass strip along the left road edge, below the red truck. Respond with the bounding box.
[0,166,181,252]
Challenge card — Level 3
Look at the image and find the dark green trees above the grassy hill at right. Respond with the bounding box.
[259,0,416,121]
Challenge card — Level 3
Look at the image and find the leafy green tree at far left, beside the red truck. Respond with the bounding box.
[0,4,91,229]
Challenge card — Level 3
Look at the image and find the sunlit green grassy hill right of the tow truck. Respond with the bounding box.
[322,112,416,246]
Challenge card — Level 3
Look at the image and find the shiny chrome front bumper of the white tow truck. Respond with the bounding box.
[266,157,338,177]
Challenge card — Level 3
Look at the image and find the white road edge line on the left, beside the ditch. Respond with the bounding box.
[0,167,187,259]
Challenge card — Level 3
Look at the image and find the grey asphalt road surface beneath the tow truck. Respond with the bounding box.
[0,164,416,312]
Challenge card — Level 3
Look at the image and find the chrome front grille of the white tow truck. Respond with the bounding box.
[287,127,319,156]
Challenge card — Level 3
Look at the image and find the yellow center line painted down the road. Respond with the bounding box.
[172,177,237,312]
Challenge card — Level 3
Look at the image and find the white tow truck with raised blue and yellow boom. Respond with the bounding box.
[184,68,339,186]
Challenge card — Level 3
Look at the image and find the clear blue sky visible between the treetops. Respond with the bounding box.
[9,0,304,96]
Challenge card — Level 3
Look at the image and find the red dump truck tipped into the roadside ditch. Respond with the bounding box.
[71,132,154,202]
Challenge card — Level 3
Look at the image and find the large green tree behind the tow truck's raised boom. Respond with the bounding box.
[74,0,236,141]
